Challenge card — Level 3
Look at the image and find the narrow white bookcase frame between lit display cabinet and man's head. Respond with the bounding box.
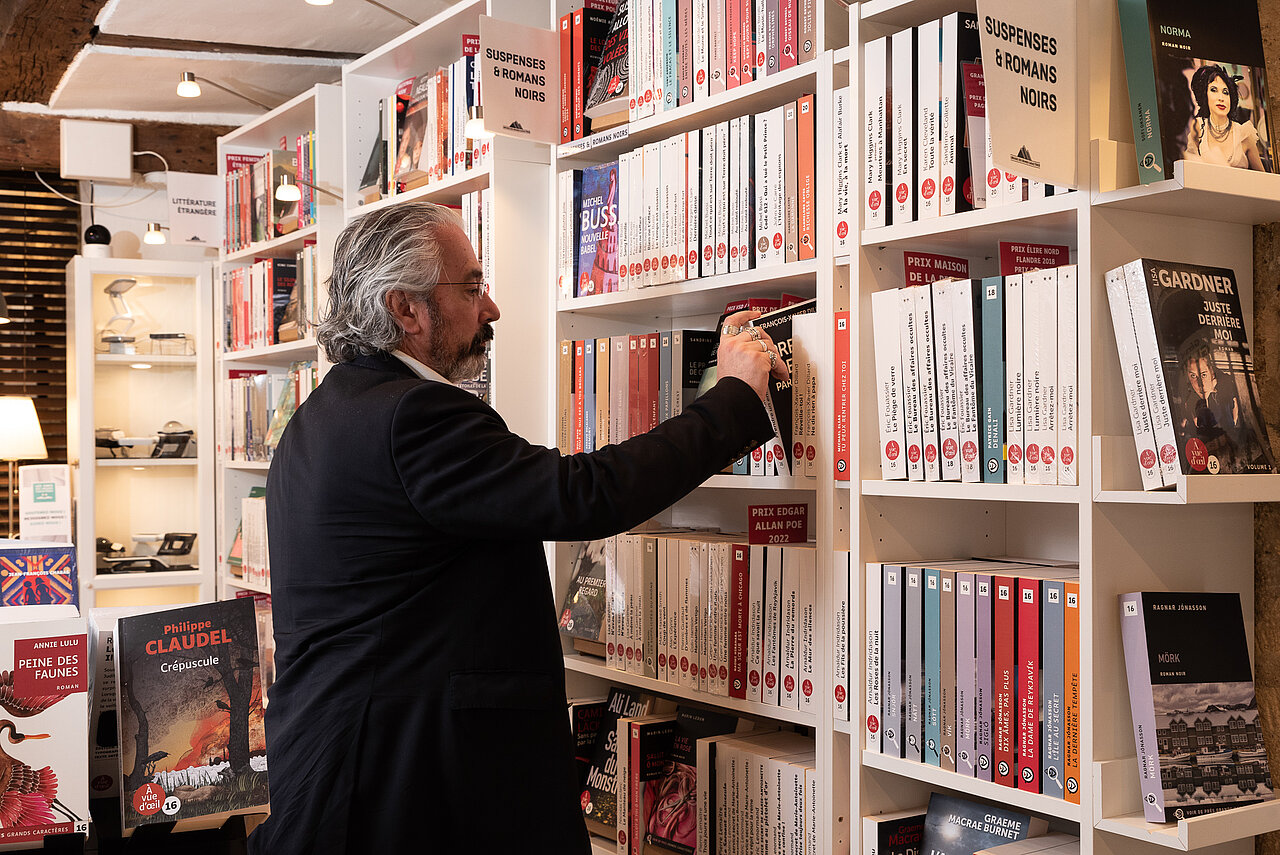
[212,83,342,599]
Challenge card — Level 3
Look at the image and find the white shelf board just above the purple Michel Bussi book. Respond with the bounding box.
[557,61,820,163]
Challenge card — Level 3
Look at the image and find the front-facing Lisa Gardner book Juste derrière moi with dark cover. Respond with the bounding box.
[1125,259,1276,481]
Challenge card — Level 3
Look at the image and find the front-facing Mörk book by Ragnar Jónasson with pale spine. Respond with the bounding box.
[1120,591,1275,823]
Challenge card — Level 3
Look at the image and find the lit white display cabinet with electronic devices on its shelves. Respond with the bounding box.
[67,256,215,608]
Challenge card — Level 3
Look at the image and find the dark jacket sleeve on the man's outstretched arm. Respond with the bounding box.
[392,378,773,540]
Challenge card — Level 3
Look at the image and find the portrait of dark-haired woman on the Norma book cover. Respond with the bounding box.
[1162,59,1275,172]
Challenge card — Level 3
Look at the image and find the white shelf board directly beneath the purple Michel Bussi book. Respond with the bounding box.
[558,260,818,325]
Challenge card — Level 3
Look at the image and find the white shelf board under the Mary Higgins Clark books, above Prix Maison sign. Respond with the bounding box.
[861,193,1084,262]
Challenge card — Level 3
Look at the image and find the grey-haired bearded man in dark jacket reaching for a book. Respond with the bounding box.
[250,204,786,855]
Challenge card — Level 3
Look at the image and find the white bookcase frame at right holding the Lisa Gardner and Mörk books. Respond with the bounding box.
[835,0,1280,855]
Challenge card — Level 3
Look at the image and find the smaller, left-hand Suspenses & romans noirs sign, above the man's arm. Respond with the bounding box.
[480,15,559,145]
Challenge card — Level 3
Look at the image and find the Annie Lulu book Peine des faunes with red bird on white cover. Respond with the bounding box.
[0,605,88,850]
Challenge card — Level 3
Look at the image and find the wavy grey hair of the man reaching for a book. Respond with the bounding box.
[316,202,461,362]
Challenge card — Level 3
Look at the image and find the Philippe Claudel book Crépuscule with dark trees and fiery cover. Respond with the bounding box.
[115,599,268,836]
